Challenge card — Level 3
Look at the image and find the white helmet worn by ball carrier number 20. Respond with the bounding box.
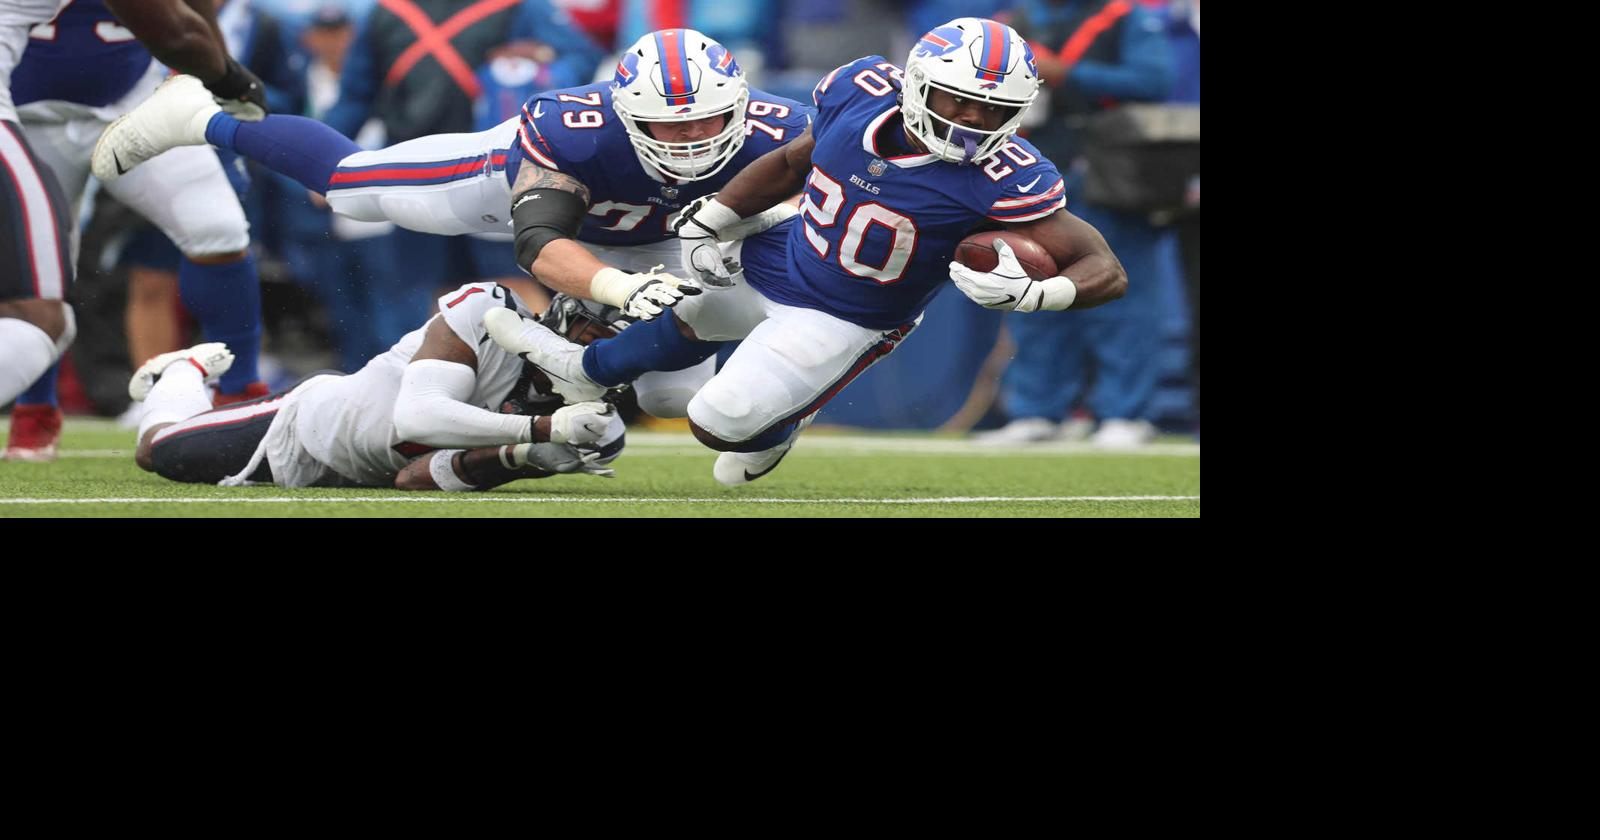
[901,18,1040,163]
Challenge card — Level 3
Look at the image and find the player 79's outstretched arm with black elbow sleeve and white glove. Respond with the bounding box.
[510,158,701,320]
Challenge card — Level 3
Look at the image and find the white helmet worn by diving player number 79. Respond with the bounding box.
[611,29,750,181]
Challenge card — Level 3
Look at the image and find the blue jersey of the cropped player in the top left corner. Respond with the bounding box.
[11,0,155,107]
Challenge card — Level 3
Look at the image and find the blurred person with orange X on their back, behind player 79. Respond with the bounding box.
[322,0,602,323]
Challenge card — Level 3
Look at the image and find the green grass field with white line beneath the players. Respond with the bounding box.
[0,419,1200,518]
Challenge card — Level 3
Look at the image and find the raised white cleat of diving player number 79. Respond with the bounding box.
[90,75,222,184]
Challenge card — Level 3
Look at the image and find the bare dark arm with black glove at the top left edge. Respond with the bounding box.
[106,0,267,120]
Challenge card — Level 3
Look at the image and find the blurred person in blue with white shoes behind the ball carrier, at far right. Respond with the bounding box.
[979,0,1173,446]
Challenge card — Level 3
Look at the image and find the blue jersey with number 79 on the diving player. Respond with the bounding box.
[507,82,813,245]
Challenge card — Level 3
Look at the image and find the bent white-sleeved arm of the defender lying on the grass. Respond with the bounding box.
[394,317,611,448]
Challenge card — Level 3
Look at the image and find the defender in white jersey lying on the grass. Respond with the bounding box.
[128,283,624,491]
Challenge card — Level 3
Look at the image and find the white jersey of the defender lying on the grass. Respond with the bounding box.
[281,283,533,486]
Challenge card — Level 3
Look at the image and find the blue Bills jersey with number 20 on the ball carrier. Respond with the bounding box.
[742,56,1066,330]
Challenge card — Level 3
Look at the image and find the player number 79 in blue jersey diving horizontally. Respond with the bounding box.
[94,29,811,416]
